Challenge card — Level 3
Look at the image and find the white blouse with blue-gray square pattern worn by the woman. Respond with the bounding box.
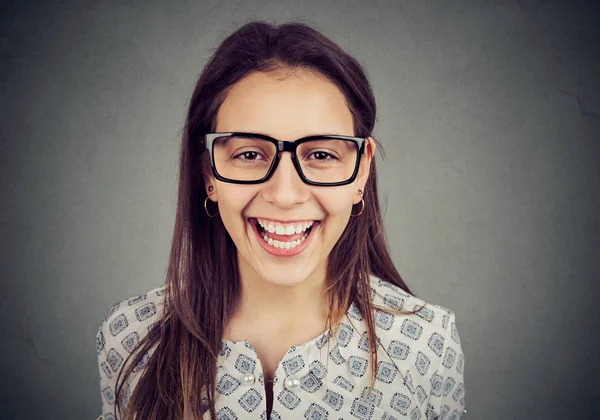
[97,277,466,420]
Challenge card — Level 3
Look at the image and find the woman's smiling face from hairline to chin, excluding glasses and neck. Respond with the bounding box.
[206,71,375,286]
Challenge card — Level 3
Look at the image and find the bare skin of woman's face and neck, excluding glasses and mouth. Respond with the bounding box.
[206,70,375,342]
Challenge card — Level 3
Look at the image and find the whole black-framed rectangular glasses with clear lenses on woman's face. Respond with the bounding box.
[204,132,366,187]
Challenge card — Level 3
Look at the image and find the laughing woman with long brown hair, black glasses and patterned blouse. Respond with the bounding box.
[98,22,464,419]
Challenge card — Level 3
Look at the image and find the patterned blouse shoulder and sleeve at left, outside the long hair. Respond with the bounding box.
[96,285,165,413]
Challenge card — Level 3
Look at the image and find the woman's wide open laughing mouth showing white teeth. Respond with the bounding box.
[248,218,319,255]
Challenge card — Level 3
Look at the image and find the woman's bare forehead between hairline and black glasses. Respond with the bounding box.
[216,70,354,140]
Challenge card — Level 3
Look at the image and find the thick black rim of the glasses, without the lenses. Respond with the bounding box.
[203,131,367,187]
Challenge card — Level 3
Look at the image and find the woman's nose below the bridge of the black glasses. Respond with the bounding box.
[262,152,310,208]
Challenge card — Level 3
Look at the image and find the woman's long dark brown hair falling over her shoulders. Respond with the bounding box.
[114,21,414,420]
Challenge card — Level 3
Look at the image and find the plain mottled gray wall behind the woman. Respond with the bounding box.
[0,0,600,419]
